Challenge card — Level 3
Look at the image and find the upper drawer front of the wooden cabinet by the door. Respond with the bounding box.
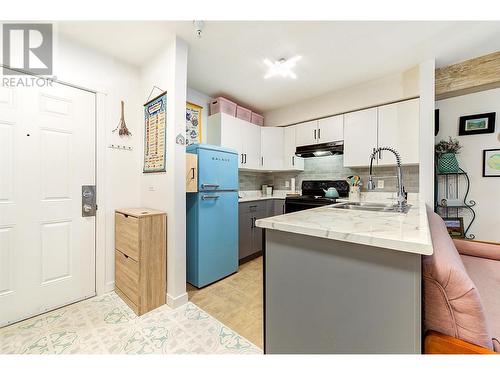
[115,212,139,261]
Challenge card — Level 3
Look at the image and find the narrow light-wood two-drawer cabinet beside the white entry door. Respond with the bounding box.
[115,208,167,315]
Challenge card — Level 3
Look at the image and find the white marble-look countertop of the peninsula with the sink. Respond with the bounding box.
[256,201,433,255]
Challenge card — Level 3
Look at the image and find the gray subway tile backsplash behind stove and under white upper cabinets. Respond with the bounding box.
[239,155,419,193]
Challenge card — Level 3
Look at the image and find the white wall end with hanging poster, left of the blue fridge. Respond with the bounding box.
[140,36,187,307]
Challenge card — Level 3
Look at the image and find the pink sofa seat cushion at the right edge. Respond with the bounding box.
[462,255,500,351]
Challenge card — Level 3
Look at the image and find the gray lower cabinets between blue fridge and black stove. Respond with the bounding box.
[238,199,285,260]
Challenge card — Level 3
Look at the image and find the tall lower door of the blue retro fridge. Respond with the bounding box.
[192,192,238,287]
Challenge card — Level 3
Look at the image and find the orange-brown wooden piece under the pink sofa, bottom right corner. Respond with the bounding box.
[424,331,498,354]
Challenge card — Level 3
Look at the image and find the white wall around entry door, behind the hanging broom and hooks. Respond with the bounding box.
[54,35,142,293]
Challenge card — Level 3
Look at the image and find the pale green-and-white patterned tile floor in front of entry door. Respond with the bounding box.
[0,293,262,354]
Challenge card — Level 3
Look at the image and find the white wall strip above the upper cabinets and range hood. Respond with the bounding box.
[264,67,420,126]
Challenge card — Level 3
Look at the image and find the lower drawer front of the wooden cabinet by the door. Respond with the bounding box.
[115,250,139,305]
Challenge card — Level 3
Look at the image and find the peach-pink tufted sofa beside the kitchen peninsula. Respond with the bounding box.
[422,212,500,353]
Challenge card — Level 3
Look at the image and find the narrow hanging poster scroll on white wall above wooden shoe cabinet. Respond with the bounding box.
[143,91,167,173]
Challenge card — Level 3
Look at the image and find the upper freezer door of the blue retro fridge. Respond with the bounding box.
[198,148,238,191]
